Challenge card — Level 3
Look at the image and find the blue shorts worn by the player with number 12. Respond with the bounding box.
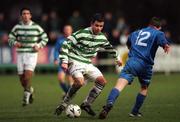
[119,58,152,86]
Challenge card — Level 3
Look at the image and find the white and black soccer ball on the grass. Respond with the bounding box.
[65,104,81,118]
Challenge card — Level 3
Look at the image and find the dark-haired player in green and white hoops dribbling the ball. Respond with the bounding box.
[55,13,122,116]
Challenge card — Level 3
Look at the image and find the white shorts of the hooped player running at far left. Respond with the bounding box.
[17,53,38,74]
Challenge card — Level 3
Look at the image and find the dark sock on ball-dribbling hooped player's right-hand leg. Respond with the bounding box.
[84,82,104,105]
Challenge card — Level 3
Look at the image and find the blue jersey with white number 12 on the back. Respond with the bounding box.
[127,26,168,65]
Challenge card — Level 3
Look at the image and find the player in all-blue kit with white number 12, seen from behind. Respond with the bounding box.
[99,17,170,119]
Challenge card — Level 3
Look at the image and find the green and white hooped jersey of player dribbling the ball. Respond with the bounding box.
[59,27,118,64]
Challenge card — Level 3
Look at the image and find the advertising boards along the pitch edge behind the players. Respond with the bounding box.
[0,45,180,73]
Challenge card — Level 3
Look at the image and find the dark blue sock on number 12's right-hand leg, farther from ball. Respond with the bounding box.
[132,93,146,113]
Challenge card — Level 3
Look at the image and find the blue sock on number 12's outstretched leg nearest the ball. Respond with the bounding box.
[107,88,120,105]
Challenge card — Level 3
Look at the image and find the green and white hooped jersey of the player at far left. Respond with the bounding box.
[8,21,48,53]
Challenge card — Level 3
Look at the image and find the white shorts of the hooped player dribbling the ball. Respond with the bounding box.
[68,62,103,82]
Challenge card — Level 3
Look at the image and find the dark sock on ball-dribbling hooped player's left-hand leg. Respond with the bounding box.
[63,84,81,104]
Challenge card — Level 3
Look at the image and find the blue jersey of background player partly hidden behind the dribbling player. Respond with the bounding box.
[54,36,66,60]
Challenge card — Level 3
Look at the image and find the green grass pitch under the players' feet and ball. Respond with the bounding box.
[0,73,180,122]
